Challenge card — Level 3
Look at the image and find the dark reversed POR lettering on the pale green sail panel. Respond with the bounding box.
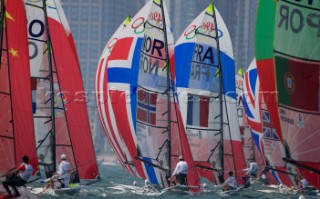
[278,4,320,37]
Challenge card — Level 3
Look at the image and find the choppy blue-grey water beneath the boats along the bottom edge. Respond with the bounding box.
[30,165,320,199]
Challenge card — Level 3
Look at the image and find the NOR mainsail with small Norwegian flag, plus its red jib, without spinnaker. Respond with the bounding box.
[136,0,200,187]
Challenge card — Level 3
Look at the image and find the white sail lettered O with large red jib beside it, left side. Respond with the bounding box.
[25,0,98,193]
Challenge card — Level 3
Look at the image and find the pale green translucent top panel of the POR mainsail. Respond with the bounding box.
[274,0,320,61]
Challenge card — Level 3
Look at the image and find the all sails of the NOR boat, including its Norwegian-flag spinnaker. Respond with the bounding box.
[95,0,199,191]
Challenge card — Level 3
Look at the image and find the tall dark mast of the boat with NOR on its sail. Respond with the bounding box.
[160,0,171,184]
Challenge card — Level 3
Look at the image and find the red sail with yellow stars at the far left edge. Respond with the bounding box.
[0,0,38,174]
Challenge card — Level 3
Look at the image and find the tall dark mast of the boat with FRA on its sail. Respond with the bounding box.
[212,2,224,183]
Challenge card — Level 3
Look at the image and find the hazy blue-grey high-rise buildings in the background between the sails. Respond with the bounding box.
[62,0,258,150]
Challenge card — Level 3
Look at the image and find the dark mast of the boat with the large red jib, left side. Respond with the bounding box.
[43,0,57,171]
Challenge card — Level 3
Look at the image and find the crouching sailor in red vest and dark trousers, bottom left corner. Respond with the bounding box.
[2,156,33,198]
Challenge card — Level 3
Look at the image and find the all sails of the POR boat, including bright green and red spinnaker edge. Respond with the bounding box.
[256,0,320,189]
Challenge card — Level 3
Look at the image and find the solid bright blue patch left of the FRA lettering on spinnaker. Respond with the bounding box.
[174,43,195,88]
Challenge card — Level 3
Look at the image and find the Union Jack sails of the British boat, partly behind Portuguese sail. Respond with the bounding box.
[242,59,296,187]
